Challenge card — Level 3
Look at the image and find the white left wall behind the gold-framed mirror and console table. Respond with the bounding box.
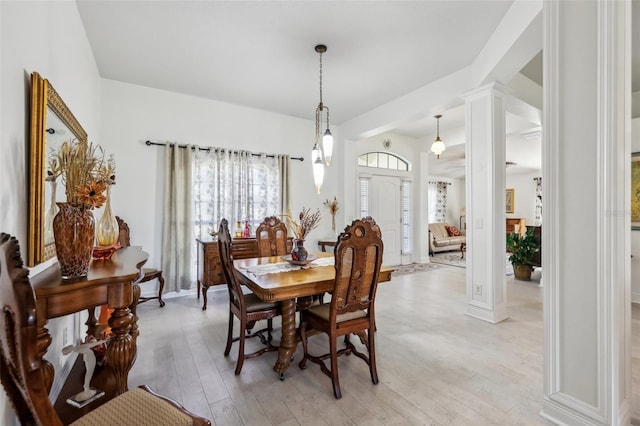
[0,1,100,425]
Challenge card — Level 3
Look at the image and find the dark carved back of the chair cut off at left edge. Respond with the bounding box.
[0,233,62,426]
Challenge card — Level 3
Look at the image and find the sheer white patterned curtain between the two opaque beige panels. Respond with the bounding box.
[193,149,282,237]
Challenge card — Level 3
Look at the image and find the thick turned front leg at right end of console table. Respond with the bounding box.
[107,307,136,395]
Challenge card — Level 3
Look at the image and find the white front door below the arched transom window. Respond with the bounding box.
[371,175,402,265]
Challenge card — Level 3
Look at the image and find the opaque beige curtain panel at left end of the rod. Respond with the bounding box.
[162,144,194,292]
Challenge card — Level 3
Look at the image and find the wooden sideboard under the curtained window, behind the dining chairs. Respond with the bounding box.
[196,237,293,311]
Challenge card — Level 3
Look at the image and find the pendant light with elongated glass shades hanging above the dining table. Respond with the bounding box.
[311,44,333,194]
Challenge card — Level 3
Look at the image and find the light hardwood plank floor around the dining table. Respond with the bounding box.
[129,266,640,425]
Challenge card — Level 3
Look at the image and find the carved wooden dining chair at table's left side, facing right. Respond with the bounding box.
[218,219,282,375]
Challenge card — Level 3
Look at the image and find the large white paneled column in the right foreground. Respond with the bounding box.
[541,1,638,425]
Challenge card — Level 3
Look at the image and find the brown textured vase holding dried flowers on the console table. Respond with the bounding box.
[53,203,95,279]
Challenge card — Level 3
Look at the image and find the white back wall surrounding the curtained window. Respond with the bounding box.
[101,79,346,272]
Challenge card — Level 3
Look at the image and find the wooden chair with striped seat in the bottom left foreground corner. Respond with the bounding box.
[0,233,211,426]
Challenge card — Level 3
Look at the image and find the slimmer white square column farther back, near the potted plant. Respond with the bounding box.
[464,82,508,323]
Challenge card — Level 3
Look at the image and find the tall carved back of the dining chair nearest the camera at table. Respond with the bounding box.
[330,218,384,323]
